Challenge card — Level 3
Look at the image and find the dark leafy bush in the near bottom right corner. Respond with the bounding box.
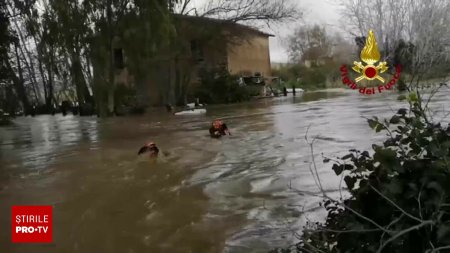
[290,101,450,253]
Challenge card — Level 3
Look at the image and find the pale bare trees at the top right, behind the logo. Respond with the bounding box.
[341,0,450,126]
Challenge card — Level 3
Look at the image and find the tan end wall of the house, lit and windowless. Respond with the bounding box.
[228,35,272,76]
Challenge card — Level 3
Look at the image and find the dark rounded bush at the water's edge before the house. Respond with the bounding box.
[193,69,256,104]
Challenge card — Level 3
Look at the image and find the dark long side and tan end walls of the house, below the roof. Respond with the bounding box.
[115,20,271,105]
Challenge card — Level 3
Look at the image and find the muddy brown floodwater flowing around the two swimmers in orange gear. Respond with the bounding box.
[0,87,450,253]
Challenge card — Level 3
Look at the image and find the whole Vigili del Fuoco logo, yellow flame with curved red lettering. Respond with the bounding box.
[341,30,401,95]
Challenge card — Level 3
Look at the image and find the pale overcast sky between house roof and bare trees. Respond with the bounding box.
[189,0,340,62]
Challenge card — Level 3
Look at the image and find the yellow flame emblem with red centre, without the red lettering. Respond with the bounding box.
[352,30,388,83]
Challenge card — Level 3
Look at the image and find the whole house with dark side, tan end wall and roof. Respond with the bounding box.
[114,15,273,105]
